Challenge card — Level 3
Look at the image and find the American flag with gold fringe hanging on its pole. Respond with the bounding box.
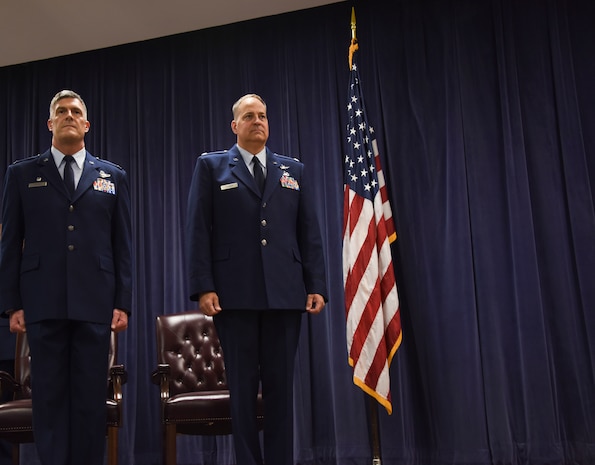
[343,57,402,414]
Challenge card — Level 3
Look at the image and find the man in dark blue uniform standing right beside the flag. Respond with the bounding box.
[187,94,327,465]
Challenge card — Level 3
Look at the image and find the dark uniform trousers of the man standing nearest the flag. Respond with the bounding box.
[213,309,303,465]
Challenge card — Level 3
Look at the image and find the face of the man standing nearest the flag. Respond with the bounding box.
[231,97,269,148]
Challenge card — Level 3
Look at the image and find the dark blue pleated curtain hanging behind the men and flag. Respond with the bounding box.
[0,0,595,465]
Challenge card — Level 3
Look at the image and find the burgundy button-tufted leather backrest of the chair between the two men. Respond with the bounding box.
[156,311,228,396]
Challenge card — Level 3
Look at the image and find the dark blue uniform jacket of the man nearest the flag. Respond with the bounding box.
[187,145,327,310]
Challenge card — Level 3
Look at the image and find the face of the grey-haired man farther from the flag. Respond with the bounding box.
[48,97,91,142]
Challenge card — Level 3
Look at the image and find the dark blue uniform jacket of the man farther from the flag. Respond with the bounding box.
[0,150,132,324]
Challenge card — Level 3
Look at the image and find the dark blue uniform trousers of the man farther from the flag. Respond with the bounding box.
[27,320,111,465]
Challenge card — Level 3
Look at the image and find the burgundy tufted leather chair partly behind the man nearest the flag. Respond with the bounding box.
[152,311,264,465]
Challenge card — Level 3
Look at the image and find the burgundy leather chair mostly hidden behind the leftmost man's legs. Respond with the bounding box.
[0,332,127,465]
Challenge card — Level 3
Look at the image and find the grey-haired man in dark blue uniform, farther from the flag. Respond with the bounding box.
[0,90,132,465]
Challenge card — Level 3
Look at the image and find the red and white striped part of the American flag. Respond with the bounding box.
[343,141,402,414]
